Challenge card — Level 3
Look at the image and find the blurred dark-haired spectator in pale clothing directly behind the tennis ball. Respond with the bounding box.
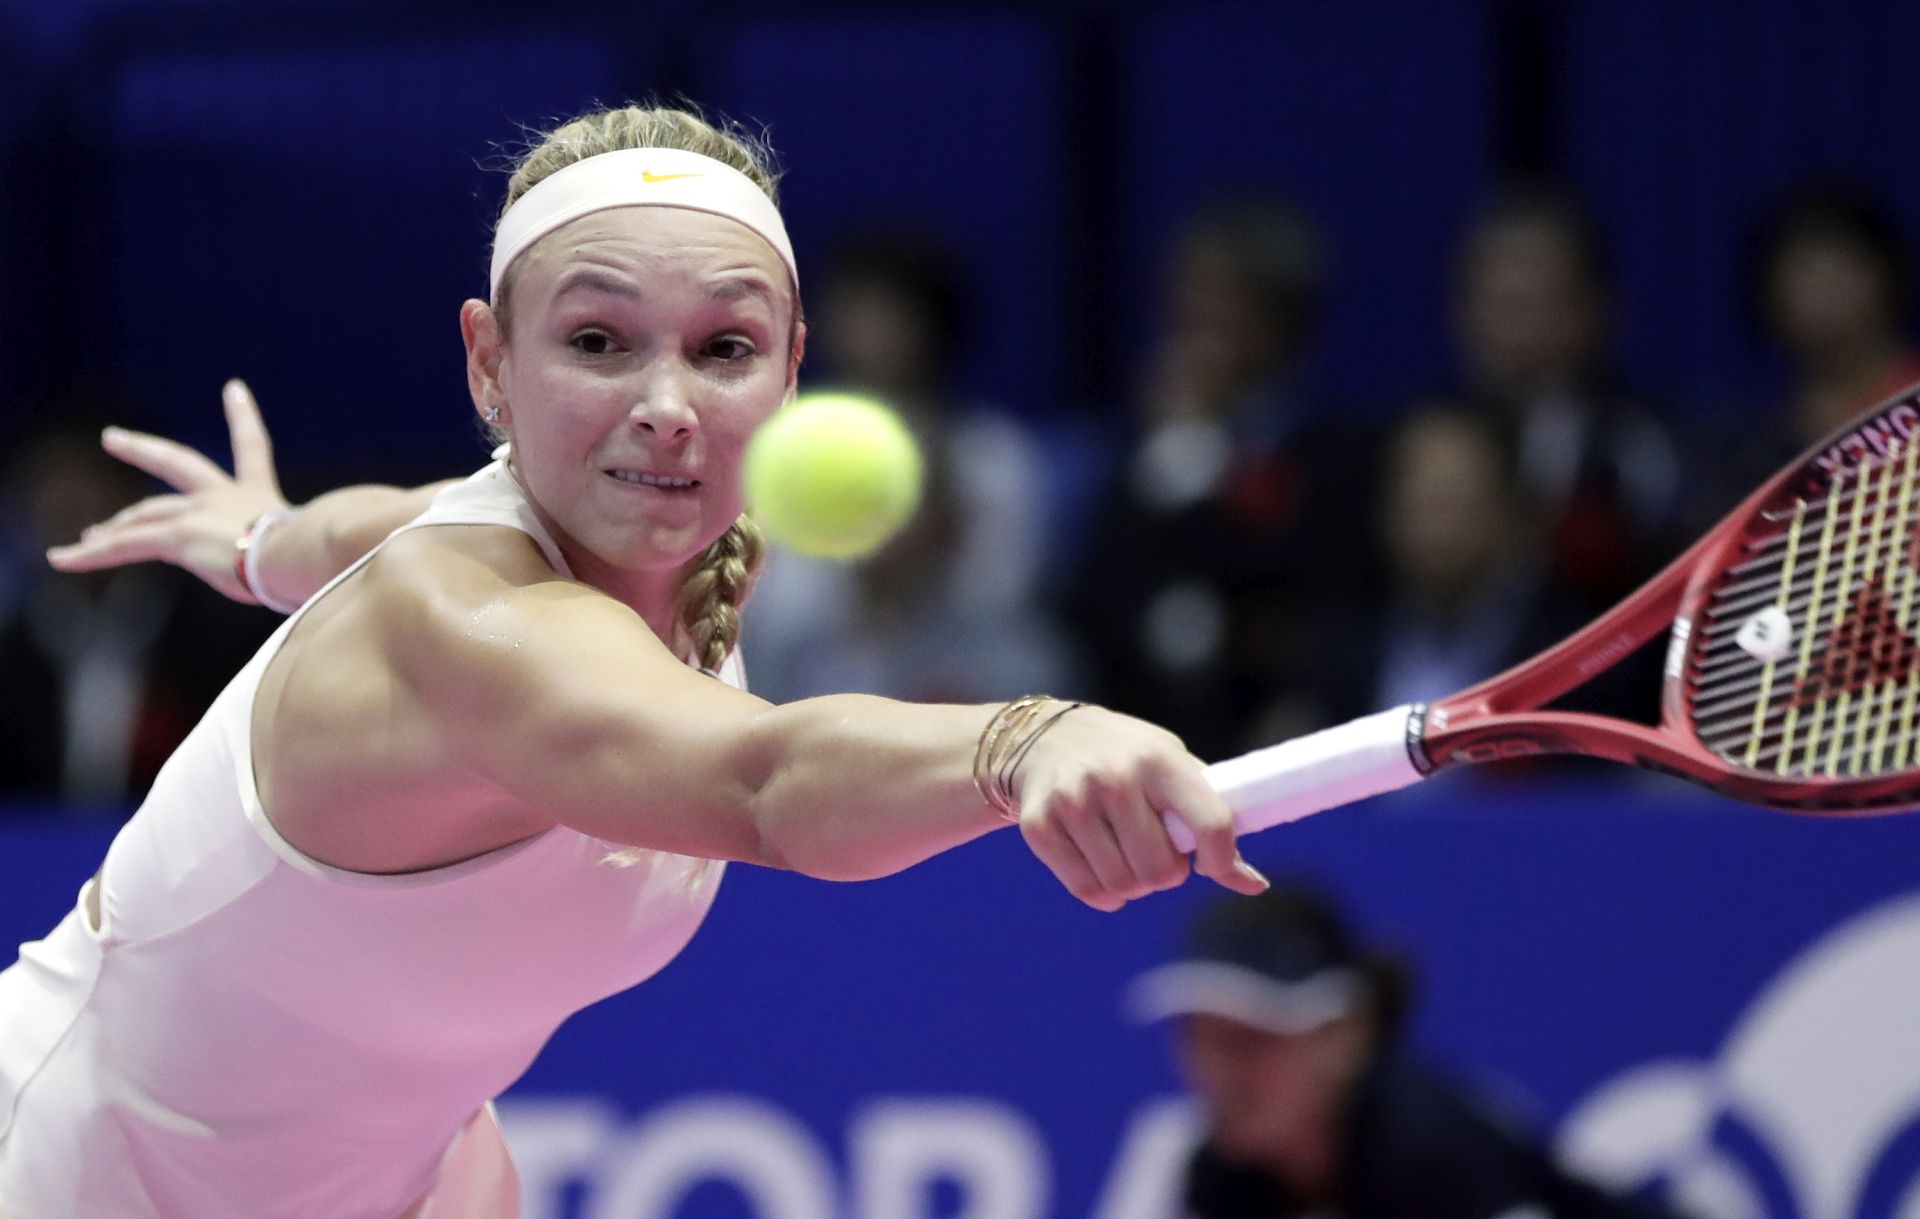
[743,234,1075,703]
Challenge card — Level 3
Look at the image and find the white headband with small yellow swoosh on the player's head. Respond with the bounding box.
[488,148,801,298]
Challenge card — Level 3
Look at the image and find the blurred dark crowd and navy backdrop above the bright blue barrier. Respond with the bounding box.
[0,0,1920,816]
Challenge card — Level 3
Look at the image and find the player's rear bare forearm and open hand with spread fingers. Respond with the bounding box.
[46,380,447,605]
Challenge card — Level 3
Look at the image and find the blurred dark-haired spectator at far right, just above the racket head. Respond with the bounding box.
[1749,190,1920,453]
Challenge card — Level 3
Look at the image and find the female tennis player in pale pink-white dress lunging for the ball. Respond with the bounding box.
[0,109,1263,1219]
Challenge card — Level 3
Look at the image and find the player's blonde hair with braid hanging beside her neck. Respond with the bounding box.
[493,106,801,672]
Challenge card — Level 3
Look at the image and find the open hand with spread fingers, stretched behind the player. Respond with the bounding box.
[46,380,286,605]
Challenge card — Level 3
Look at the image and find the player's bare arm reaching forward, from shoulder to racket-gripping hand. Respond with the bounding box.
[368,530,1265,910]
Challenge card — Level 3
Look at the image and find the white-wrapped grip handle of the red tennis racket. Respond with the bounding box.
[1162,703,1427,850]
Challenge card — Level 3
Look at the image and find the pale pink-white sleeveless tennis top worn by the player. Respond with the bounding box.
[0,463,739,1219]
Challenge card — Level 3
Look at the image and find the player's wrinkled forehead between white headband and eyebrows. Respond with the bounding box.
[513,207,793,301]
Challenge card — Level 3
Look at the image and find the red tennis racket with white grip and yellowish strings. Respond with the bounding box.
[1167,384,1920,850]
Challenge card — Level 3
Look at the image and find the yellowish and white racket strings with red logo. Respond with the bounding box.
[1690,445,1920,776]
